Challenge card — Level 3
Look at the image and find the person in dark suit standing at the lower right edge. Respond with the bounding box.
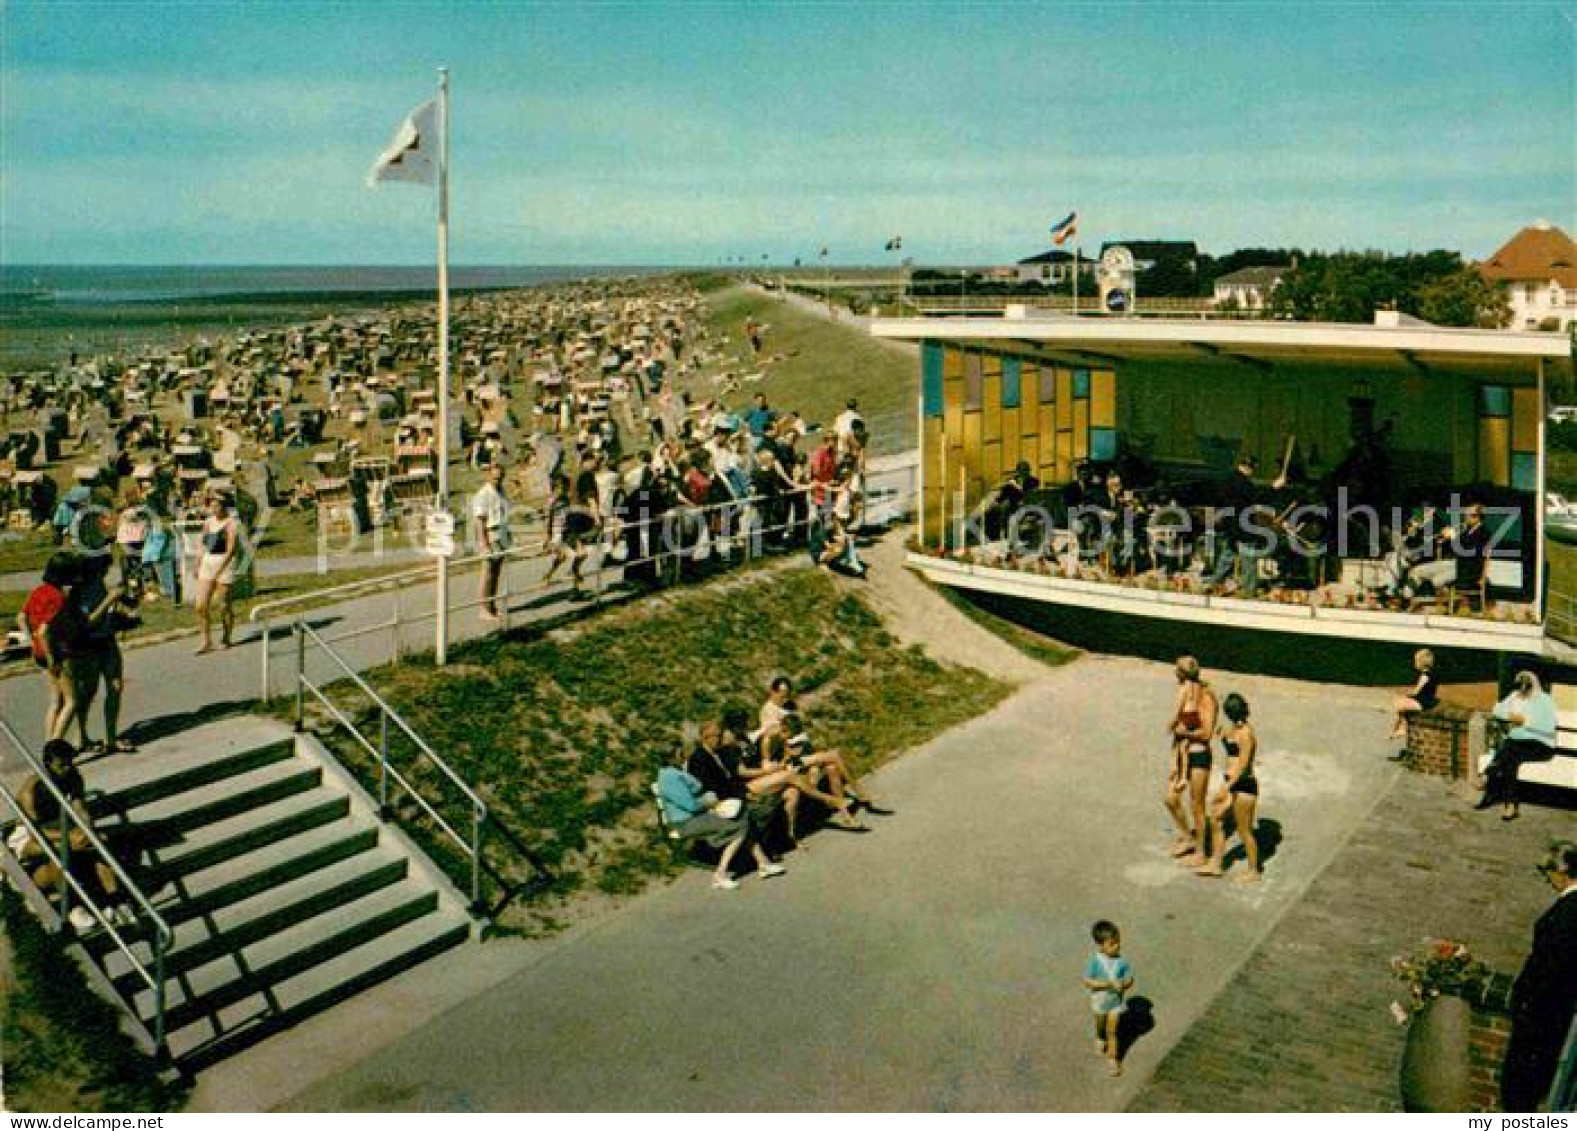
[1500,841,1577,1112]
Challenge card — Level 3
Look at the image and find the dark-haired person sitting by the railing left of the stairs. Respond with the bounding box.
[17,738,136,931]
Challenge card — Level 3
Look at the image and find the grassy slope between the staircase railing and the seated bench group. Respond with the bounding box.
[307,569,1011,929]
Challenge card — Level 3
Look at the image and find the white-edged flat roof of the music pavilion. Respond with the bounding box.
[871,312,1572,377]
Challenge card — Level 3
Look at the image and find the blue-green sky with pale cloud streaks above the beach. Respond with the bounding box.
[0,0,1577,265]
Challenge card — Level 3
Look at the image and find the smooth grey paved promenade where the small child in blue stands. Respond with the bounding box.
[246,656,1399,1110]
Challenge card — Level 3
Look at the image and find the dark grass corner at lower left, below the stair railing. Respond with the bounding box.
[0,888,185,1112]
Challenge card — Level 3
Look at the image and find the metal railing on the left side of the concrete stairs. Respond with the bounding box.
[0,719,173,1058]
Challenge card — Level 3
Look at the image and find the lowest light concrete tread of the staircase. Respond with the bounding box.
[142,880,438,1033]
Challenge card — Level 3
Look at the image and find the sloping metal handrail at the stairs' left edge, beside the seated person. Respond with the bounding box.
[0,719,175,1055]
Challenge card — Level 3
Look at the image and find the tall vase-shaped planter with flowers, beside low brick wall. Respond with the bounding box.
[1391,939,1490,1112]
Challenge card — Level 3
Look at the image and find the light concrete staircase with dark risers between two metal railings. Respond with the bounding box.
[80,718,473,1071]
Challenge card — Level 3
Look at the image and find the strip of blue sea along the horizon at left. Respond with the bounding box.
[0,263,672,304]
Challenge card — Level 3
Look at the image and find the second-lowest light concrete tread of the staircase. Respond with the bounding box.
[103,849,410,997]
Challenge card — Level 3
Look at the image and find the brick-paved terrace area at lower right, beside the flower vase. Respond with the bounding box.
[1131,775,1572,1112]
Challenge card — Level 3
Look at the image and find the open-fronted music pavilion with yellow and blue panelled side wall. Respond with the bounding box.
[872,308,1571,681]
